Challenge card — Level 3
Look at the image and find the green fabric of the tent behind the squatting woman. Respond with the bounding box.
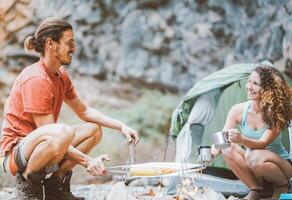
[170,61,292,168]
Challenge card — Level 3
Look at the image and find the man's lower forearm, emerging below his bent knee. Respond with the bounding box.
[65,145,91,168]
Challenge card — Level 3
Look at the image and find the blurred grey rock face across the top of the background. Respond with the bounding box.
[0,0,292,90]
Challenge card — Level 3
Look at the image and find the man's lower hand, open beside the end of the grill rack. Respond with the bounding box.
[86,155,110,176]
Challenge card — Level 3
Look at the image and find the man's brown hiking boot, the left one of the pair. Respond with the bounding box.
[16,172,44,200]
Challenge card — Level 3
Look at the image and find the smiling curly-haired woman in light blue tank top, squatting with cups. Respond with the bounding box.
[212,65,292,199]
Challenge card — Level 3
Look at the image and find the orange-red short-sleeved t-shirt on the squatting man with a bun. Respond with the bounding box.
[0,58,76,156]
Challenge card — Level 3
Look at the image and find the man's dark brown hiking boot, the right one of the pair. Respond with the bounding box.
[44,171,85,200]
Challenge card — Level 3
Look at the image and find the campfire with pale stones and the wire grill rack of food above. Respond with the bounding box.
[107,162,236,200]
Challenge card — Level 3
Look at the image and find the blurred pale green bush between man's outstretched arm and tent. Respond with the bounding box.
[111,90,179,138]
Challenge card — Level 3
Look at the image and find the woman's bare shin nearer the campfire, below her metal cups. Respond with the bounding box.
[222,144,259,189]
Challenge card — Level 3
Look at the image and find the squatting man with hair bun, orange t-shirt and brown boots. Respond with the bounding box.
[0,18,139,200]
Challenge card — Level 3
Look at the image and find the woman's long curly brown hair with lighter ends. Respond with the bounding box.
[255,65,292,132]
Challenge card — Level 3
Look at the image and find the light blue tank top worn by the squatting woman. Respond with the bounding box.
[240,101,290,159]
